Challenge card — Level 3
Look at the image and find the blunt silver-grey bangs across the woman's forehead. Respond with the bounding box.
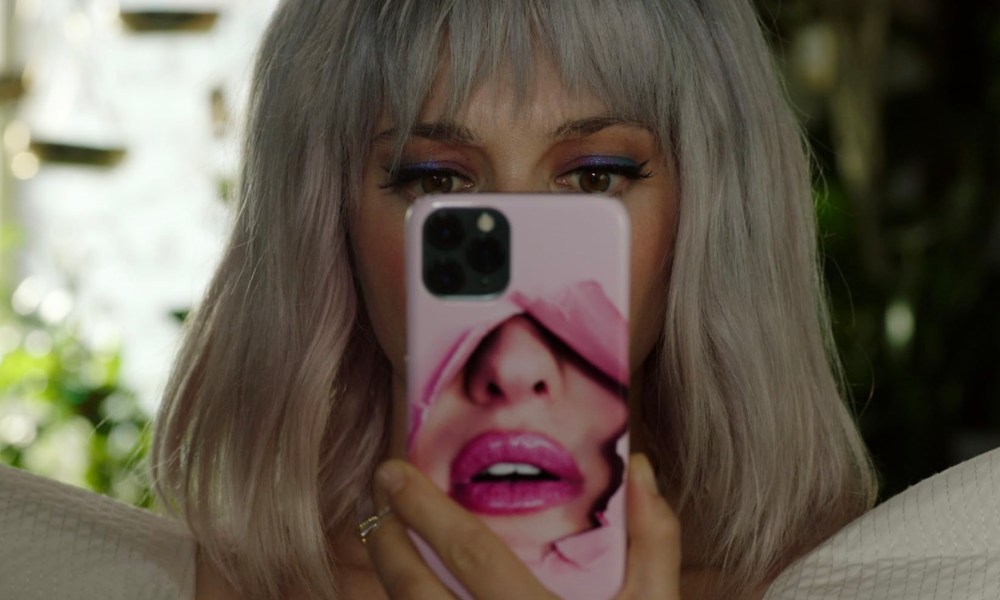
[359,0,674,164]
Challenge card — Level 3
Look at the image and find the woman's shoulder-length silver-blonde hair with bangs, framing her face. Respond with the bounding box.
[151,0,875,598]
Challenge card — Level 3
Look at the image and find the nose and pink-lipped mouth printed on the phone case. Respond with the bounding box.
[410,316,628,550]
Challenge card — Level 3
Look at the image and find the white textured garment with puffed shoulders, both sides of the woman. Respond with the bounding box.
[0,450,1000,600]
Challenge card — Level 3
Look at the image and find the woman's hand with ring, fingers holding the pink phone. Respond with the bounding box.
[367,454,681,600]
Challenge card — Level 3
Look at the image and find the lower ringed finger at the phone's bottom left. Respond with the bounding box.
[365,496,455,600]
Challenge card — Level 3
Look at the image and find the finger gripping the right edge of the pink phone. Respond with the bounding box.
[619,454,681,600]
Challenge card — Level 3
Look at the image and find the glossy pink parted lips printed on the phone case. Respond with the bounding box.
[450,431,583,515]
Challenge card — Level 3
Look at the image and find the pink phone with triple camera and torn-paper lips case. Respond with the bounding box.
[406,194,629,599]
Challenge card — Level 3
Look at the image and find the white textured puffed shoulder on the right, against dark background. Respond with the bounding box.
[765,449,1000,600]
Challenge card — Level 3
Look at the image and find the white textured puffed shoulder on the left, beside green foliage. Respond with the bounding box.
[0,465,195,600]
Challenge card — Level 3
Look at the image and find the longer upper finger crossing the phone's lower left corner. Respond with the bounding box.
[375,460,554,600]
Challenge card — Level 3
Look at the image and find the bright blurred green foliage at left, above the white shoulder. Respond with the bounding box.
[0,314,152,506]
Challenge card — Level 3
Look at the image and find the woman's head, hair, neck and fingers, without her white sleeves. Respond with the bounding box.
[152,0,875,598]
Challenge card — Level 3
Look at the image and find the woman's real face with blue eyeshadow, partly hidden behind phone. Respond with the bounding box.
[351,57,677,455]
